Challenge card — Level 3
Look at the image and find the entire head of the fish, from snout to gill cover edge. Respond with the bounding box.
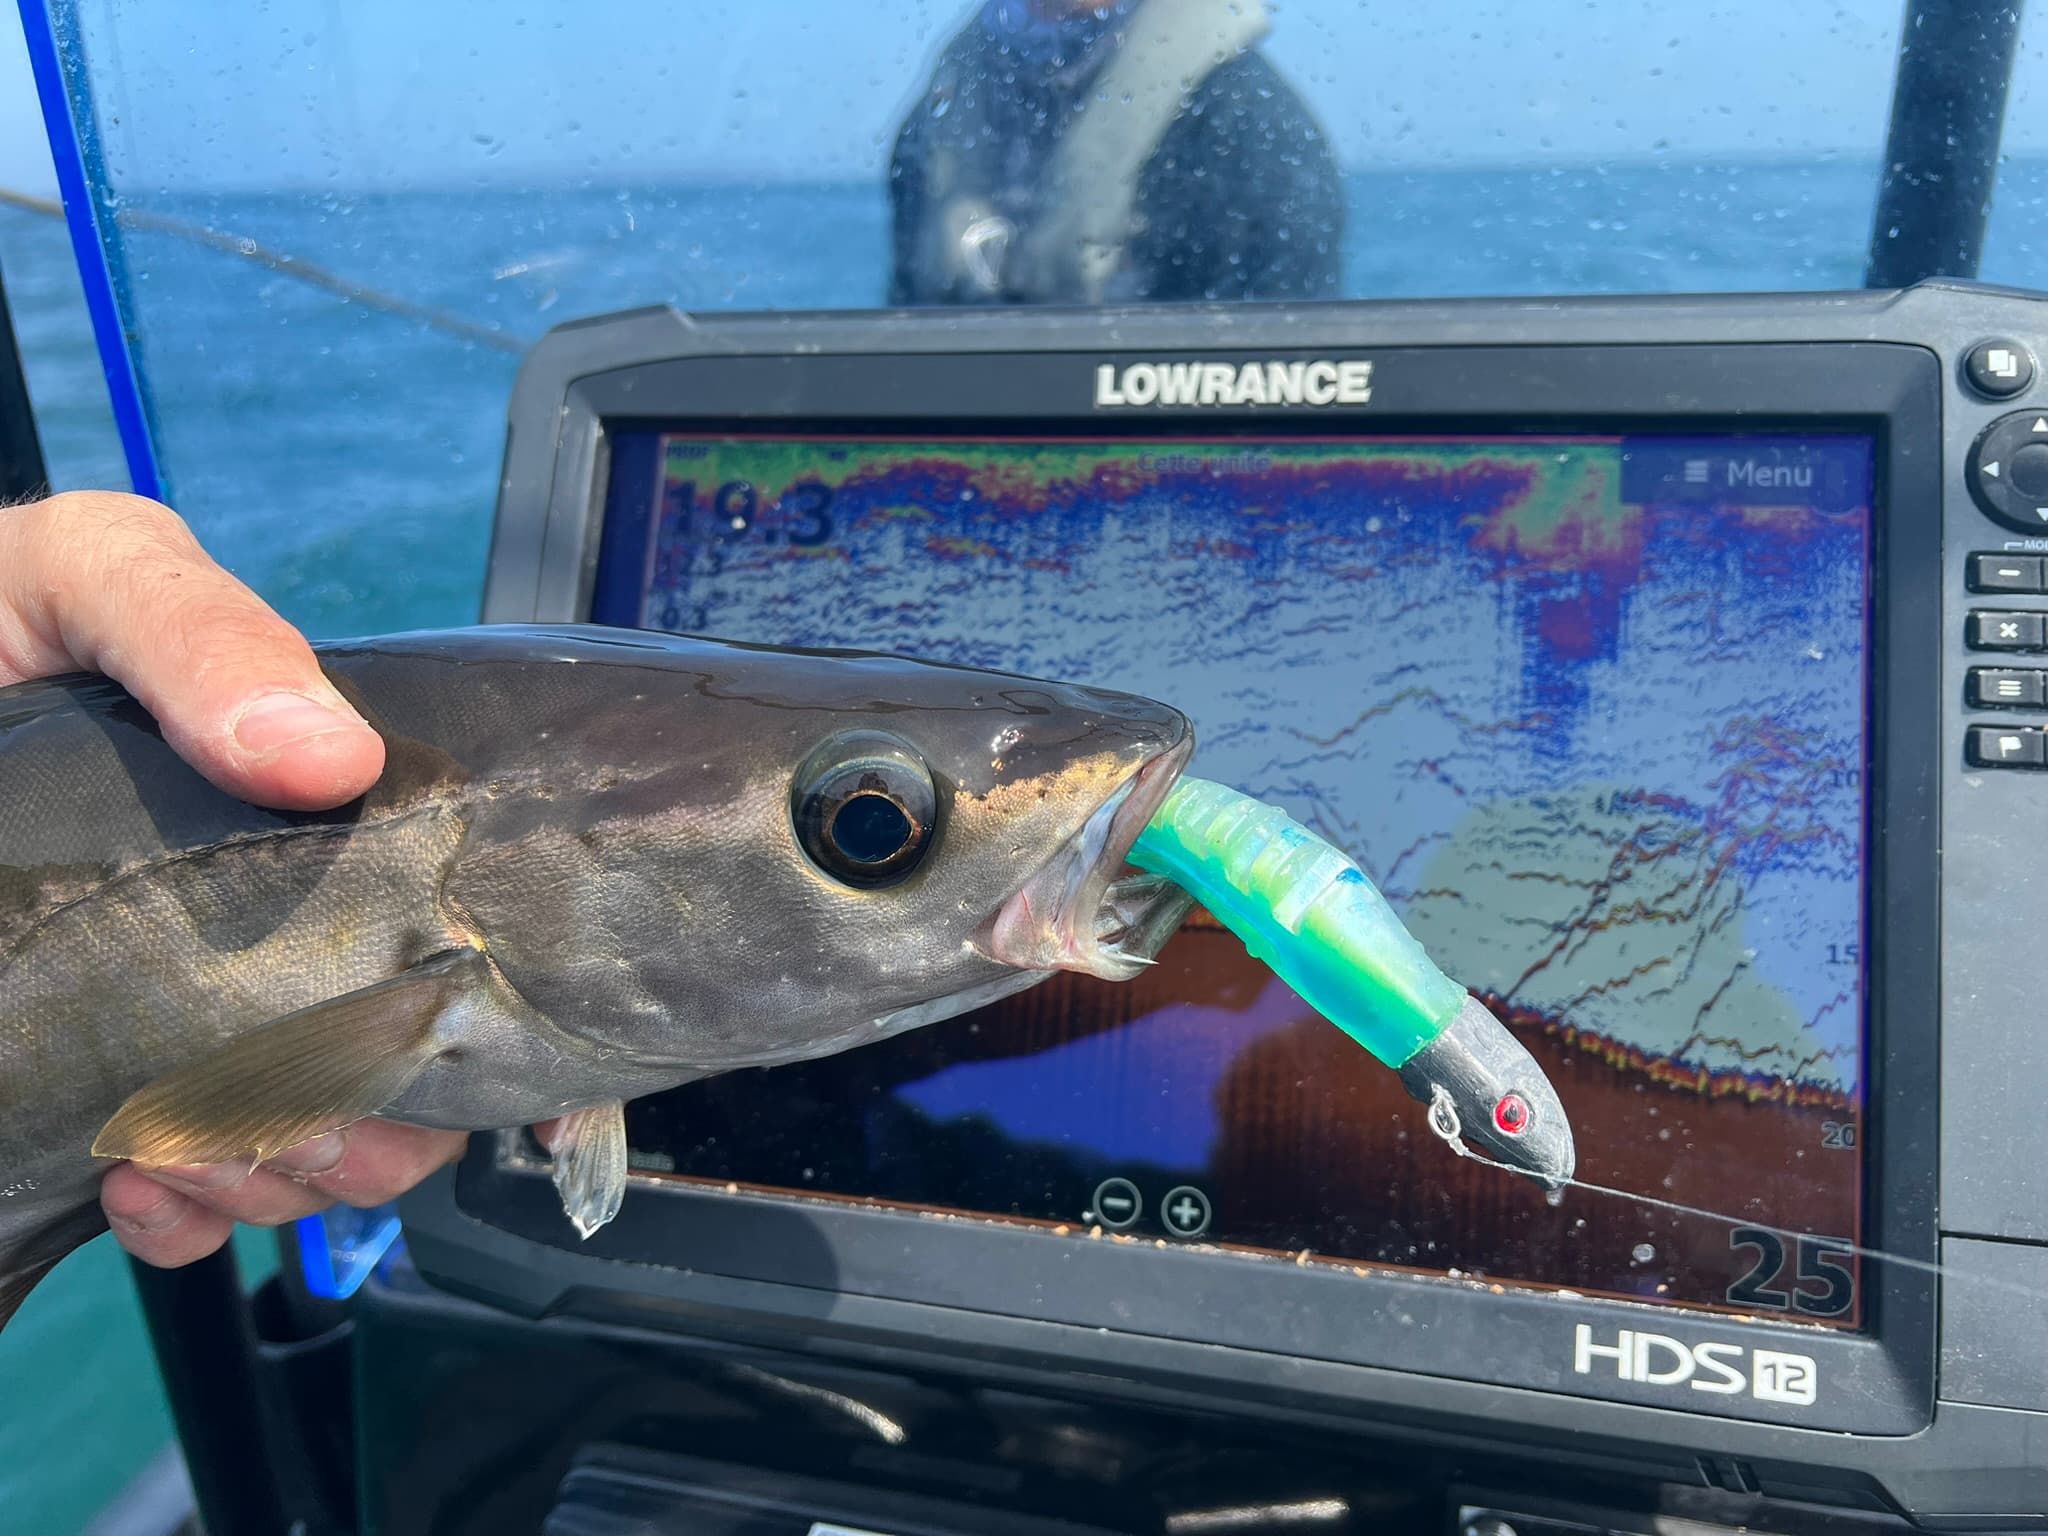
[434,629,1194,1073]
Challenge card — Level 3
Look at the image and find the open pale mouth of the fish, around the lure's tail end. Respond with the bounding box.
[973,733,1194,981]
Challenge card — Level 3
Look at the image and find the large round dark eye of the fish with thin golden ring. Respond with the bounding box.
[788,731,938,887]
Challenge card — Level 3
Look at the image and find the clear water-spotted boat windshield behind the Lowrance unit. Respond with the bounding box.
[0,0,2048,633]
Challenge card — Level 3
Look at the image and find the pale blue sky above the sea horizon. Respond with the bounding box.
[0,0,2048,193]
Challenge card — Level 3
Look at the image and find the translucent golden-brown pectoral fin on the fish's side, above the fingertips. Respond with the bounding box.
[92,948,492,1167]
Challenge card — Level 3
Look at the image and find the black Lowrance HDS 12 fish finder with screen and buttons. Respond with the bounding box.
[385,285,2048,1530]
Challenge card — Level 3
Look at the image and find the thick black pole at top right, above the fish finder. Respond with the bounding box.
[1864,0,2023,289]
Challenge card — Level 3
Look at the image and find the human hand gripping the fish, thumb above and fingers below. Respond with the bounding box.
[0,492,465,1268]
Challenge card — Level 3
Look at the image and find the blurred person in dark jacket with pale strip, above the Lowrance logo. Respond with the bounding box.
[889,0,1343,305]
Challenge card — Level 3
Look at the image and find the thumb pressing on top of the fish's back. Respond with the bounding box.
[0,492,383,809]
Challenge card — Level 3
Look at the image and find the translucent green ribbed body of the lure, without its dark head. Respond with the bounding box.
[1128,776,1468,1069]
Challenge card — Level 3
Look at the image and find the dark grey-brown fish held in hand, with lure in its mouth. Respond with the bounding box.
[0,625,1194,1325]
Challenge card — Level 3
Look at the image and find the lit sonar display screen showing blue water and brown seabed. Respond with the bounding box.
[592,430,1872,1327]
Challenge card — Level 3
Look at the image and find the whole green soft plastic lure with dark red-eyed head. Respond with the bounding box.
[1130,776,1577,1190]
